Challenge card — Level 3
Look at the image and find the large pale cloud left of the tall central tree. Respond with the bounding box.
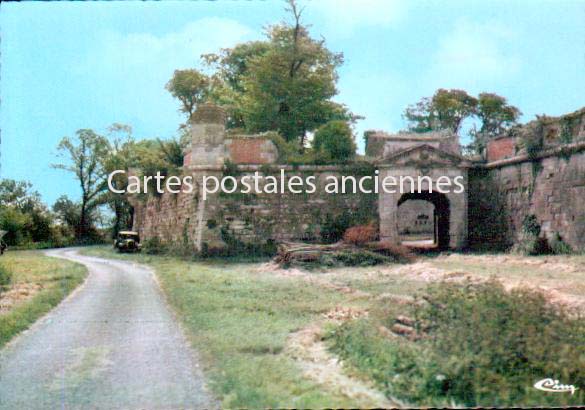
[72,18,259,130]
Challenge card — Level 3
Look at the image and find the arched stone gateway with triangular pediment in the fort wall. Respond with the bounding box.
[377,134,471,249]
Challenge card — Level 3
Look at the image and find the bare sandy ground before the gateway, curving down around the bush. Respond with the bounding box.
[268,254,585,407]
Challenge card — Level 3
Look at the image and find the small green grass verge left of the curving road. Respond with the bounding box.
[0,251,87,348]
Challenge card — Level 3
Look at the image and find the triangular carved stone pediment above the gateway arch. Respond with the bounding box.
[377,144,471,168]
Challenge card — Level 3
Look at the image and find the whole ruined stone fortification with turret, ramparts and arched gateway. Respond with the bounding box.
[131,104,585,251]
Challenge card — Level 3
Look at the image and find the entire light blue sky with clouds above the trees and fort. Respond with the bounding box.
[0,0,585,204]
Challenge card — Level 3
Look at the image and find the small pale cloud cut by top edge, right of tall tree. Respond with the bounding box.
[306,0,407,35]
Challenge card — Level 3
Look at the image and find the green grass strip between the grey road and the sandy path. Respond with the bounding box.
[83,247,359,408]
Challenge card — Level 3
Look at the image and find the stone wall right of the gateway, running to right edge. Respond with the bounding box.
[469,143,585,251]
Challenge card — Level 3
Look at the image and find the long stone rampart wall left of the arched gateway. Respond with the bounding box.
[132,165,378,250]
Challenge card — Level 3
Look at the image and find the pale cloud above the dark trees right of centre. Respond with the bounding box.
[425,20,521,92]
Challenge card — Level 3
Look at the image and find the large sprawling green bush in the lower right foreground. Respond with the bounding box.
[330,281,585,407]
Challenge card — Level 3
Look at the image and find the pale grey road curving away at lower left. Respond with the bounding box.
[0,250,217,409]
